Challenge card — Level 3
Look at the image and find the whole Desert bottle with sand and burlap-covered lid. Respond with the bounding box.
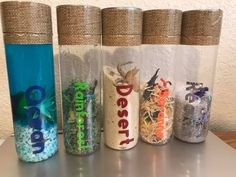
[102,7,142,150]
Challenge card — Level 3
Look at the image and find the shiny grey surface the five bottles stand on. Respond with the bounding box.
[0,133,236,177]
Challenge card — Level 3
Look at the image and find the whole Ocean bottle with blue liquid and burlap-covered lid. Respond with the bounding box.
[1,1,58,162]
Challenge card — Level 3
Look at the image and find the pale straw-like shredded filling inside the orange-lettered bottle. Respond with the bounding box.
[140,69,174,144]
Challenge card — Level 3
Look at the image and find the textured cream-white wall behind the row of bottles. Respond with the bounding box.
[0,0,236,138]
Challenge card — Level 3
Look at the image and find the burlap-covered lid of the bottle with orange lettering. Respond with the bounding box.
[142,9,182,44]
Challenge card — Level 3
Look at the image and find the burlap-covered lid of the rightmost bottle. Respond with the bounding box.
[181,9,223,45]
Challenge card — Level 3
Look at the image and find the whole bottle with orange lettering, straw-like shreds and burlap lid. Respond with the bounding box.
[140,9,182,145]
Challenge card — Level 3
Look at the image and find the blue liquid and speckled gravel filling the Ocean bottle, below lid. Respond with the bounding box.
[5,44,58,162]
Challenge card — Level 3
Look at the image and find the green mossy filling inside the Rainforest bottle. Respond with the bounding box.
[62,81,100,155]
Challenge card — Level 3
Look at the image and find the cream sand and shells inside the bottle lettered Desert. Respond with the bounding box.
[103,65,139,150]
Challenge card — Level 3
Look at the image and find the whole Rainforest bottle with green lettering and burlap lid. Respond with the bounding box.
[57,5,101,155]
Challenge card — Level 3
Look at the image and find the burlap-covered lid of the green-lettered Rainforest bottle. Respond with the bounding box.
[57,5,101,45]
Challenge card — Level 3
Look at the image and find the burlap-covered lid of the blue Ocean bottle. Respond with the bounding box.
[1,1,52,44]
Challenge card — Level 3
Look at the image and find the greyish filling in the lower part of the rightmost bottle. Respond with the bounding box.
[174,81,211,143]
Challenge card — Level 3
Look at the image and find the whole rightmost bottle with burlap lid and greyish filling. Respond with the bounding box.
[174,10,222,143]
